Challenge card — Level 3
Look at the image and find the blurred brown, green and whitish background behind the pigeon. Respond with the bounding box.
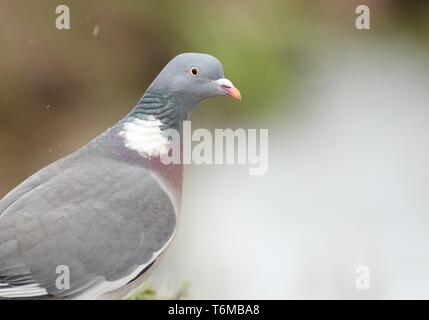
[0,0,429,299]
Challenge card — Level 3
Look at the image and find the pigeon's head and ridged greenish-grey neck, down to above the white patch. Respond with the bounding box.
[130,53,241,128]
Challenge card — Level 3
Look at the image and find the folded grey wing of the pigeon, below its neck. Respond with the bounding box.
[0,158,176,298]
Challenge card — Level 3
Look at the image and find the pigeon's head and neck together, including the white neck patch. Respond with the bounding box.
[119,53,241,157]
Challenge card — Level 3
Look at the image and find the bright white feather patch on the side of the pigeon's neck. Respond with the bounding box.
[119,118,169,157]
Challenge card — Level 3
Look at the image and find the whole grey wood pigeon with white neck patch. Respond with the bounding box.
[0,53,241,299]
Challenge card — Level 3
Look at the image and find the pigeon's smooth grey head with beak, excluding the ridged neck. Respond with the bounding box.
[148,53,241,109]
